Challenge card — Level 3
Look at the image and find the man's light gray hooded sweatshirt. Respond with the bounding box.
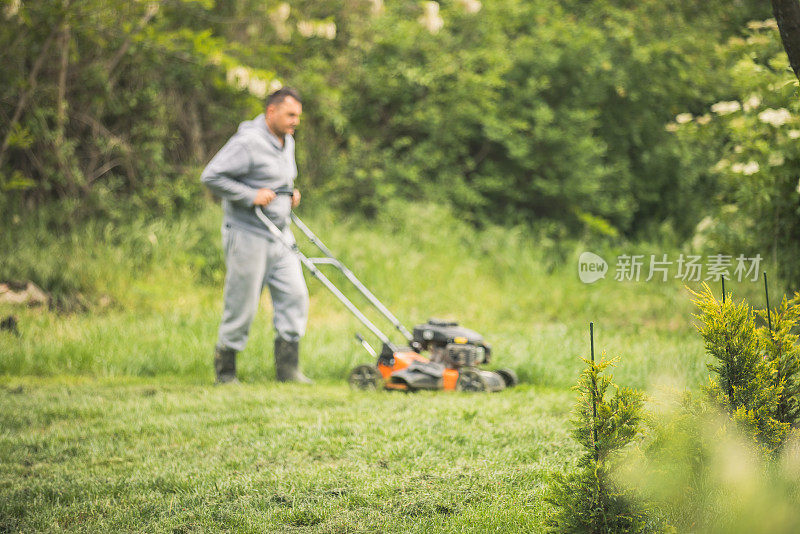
[201,113,297,237]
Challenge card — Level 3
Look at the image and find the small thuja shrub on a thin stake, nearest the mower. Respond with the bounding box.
[545,360,651,533]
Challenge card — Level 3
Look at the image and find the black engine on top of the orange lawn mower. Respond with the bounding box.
[413,319,491,369]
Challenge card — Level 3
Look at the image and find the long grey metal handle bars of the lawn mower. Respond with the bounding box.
[254,206,412,346]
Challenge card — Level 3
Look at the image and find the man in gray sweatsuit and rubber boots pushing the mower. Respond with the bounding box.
[202,88,311,384]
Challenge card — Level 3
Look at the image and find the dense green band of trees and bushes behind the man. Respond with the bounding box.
[0,0,769,236]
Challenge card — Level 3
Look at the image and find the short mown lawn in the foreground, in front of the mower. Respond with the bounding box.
[0,378,576,532]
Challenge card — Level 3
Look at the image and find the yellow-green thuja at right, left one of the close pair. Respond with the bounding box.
[694,285,794,451]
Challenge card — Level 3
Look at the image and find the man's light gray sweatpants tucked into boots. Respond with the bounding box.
[217,224,308,351]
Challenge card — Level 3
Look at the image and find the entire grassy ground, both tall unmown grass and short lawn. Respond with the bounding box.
[0,203,757,532]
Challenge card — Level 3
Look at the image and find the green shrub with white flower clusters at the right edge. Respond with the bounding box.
[668,20,800,285]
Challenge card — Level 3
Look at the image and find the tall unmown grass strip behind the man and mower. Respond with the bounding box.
[0,202,716,387]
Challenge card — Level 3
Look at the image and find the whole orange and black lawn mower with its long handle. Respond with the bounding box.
[255,201,518,392]
